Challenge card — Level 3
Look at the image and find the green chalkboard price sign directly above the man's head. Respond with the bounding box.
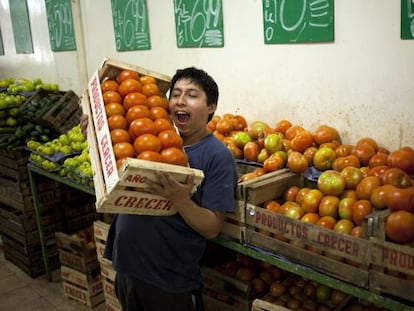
[174,0,224,48]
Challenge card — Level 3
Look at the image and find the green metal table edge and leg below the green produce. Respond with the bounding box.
[27,163,95,281]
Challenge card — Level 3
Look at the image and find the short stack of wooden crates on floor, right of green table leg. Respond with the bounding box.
[56,227,104,308]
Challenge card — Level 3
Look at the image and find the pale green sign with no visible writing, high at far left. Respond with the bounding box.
[9,0,33,54]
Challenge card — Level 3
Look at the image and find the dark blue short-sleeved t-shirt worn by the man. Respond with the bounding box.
[104,134,237,292]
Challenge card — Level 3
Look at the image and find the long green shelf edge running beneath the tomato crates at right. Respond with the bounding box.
[213,236,414,311]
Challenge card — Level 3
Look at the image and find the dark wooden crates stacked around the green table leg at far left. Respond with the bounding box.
[0,150,61,277]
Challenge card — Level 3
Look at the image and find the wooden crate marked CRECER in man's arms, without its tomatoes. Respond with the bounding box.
[81,59,204,216]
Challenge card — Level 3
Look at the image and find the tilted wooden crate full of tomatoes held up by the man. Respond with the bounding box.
[81,59,204,216]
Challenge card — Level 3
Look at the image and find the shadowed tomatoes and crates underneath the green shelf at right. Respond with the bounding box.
[204,253,385,311]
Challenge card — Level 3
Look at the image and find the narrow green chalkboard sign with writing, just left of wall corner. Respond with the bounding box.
[45,0,76,52]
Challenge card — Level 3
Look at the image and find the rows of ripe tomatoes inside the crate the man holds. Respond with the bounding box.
[101,69,188,167]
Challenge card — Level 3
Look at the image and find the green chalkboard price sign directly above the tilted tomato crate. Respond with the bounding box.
[111,0,151,52]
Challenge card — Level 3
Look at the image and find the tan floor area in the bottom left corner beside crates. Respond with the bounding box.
[0,241,106,311]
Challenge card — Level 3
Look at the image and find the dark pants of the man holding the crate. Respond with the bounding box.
[115,272,204,311]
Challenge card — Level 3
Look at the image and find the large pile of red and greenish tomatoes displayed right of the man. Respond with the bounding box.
[208,113,414,244]
